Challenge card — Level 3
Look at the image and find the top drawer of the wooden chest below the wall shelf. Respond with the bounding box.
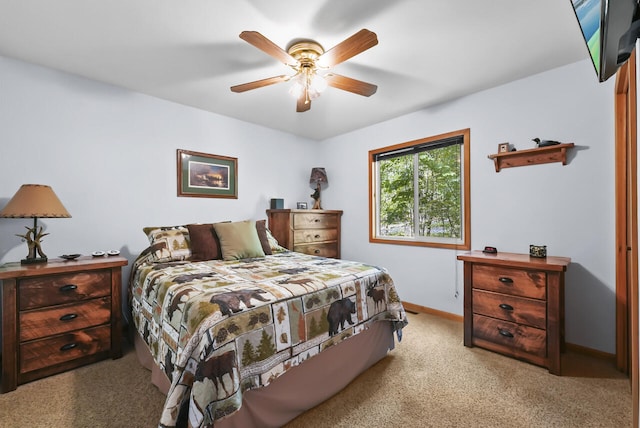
[472,264,547,299]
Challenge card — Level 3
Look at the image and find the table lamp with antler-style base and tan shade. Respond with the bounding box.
[0,184,71,264]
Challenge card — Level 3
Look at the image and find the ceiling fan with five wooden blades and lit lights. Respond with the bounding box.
[231,29,378,112]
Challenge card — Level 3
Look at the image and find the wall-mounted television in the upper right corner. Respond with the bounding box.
[571,0,640,82]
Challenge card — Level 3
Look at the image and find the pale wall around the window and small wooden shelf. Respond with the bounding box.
[323,61,615,353]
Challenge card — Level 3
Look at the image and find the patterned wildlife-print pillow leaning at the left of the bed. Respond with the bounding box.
[142,226,191,262]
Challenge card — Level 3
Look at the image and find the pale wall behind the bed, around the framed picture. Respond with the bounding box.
[0,57,318,301]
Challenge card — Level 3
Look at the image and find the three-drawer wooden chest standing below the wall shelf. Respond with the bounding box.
[458,251,571,375]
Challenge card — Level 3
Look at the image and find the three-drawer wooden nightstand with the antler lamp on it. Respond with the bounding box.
[0,256,127,392]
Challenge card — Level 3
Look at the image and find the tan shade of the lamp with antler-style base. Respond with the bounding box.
[0,184,71,218]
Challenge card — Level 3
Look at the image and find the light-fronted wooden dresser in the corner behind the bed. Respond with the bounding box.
[267,209,342,259]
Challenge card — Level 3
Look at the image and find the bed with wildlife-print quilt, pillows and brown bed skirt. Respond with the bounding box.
[129,220,407,427]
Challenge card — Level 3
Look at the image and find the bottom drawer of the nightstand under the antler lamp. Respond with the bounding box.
[20,325,111,373]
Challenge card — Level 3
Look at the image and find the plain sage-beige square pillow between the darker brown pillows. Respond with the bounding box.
[213,220,265,260]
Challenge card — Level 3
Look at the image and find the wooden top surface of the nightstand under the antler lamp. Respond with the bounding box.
[0,256,128,279]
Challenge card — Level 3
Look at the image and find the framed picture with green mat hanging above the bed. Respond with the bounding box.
[178,149,238,199]
